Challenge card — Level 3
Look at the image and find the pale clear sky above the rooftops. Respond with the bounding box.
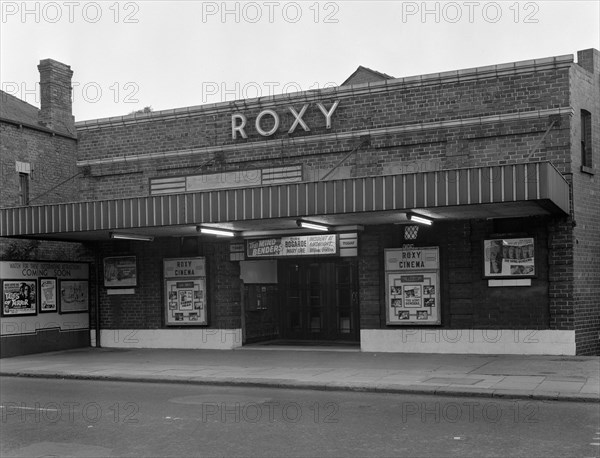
[0,0,600,121]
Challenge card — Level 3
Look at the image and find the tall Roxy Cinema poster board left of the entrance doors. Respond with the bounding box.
[163,258,208,326]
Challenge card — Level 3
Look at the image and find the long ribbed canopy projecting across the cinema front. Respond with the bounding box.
[0,162,569,240]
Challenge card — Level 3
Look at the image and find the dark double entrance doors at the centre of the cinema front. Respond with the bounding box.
[279,258,359,341]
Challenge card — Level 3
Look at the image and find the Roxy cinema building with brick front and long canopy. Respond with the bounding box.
[0,49,600,355]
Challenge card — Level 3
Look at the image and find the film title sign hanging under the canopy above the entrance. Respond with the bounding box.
[247,234,338,258]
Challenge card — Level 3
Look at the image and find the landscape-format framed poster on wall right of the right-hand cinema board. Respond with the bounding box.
[483,237,537,278]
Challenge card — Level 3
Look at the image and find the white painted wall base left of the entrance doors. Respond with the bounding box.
[96,328,242,350]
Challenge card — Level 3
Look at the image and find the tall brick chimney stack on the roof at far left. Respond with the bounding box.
[38,59,75,135]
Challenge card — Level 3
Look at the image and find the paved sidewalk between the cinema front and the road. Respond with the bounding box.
[0,346,600,402]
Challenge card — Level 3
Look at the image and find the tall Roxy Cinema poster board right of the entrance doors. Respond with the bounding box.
[384,247,441,325]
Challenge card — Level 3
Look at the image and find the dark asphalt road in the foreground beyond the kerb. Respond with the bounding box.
[0,377,600,457]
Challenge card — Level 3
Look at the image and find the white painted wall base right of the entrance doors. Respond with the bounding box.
[360,328,575,355]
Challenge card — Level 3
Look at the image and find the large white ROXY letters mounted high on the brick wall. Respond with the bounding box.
[231,100,340,140]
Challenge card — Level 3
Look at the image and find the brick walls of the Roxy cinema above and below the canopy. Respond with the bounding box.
[2,50,600,354]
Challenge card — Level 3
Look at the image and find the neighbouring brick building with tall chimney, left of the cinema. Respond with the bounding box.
[0,59,93,356]
